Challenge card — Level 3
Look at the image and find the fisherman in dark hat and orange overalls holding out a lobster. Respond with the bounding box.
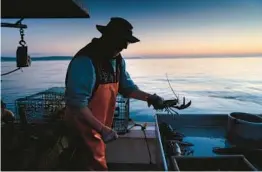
[65,17,163,171]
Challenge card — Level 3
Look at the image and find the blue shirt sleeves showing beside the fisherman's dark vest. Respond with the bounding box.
[65,57,138,108]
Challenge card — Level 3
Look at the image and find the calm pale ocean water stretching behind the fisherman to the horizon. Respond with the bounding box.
[1,57,262,120]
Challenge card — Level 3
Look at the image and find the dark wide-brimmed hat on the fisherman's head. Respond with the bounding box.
[96,17,140,43]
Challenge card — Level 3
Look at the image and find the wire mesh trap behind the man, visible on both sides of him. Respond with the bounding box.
[16,87,129,134]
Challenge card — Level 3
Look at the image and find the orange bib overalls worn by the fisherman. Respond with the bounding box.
[65,56,119,171]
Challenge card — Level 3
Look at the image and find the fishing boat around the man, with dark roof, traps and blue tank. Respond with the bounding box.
[1,0,262,171]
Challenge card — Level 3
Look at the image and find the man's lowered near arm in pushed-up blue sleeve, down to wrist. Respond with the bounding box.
[66,57,104,133]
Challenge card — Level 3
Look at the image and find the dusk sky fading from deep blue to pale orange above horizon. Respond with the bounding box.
[1,0,262,57]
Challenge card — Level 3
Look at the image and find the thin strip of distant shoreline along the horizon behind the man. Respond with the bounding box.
[1,54,262,62]
